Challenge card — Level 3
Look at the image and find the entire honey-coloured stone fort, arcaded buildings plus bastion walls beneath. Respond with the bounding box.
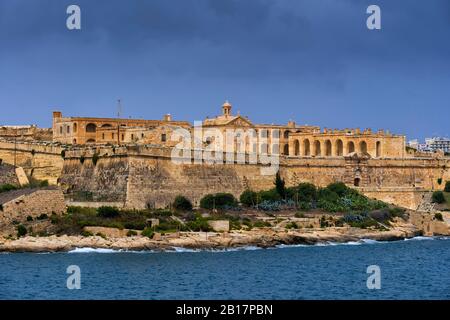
[0,102,450,209]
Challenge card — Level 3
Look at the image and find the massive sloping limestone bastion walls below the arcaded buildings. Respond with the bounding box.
[0,141,450,209]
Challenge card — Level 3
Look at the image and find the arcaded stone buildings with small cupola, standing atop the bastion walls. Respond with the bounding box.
[53,101,408,158]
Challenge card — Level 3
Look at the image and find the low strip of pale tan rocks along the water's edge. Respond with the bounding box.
[0,227,422,253]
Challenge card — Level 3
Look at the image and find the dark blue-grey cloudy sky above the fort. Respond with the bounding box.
[0,0,450,139]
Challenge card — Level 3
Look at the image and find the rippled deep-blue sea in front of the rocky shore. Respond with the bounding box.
[0,237,450,299]
